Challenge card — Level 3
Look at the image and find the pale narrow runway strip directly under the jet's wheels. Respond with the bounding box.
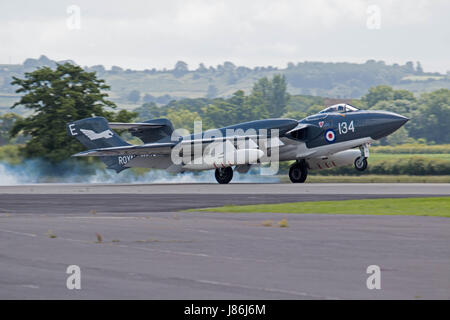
[0,183,450,196]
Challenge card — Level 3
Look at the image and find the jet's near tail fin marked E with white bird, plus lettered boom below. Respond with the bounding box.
[67,117,132,172]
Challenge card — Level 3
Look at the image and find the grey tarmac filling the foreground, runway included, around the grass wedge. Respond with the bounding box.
[0,184,450,299]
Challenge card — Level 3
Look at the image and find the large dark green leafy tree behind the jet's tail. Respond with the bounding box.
[10,63,135,164]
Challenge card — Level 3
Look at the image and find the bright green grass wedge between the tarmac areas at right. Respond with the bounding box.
[188,197,450,217]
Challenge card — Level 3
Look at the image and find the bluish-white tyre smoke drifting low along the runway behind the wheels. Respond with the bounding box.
[0,159,279,185]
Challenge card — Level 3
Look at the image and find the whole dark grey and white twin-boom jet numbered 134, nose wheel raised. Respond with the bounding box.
[67,104,409,184]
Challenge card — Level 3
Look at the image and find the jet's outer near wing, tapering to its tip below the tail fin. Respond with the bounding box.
[73,142,176,157]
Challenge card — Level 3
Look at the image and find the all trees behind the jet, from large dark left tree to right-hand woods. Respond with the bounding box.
[0,62,450,163]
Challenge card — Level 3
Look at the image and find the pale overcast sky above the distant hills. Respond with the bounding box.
[0,0,450,72]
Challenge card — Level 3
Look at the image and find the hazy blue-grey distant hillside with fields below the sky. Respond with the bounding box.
[0,56,450,113]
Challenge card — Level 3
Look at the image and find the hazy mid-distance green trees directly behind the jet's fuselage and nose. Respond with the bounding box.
[134,82,450,145]
